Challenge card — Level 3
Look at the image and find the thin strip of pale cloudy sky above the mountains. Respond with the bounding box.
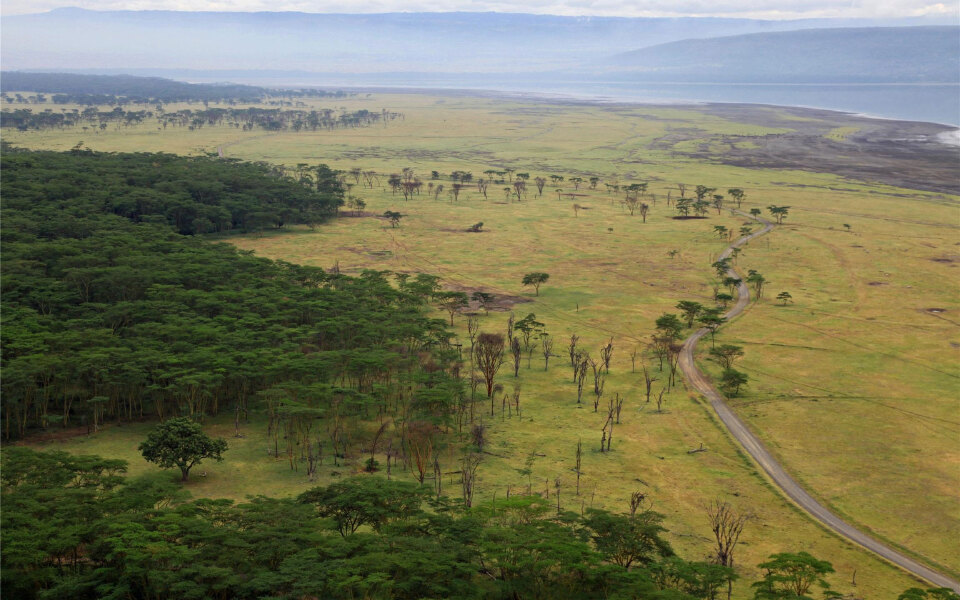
[0,0,960,19]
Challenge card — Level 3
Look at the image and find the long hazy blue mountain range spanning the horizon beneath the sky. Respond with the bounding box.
[0,8,956,85]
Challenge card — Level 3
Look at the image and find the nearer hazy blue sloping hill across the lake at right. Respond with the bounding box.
[597,27,960,83]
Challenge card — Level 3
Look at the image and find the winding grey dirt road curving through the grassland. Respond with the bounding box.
[680,211,960,593]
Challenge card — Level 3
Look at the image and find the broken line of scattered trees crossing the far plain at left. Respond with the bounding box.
[0,106,400,132]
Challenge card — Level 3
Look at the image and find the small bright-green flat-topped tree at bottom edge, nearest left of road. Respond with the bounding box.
[753,552,833,600]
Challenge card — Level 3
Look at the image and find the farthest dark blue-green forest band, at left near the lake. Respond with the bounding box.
[0,71,349,105]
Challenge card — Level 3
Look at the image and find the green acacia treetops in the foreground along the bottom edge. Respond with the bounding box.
[9,447,936,600]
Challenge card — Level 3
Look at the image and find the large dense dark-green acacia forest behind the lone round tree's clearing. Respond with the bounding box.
[0,143,456,443]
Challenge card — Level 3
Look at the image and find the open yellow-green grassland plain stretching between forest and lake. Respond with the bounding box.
[4,94,960,598]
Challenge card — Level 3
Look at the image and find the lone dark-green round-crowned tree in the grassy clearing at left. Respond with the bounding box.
[138,417,227,481]
